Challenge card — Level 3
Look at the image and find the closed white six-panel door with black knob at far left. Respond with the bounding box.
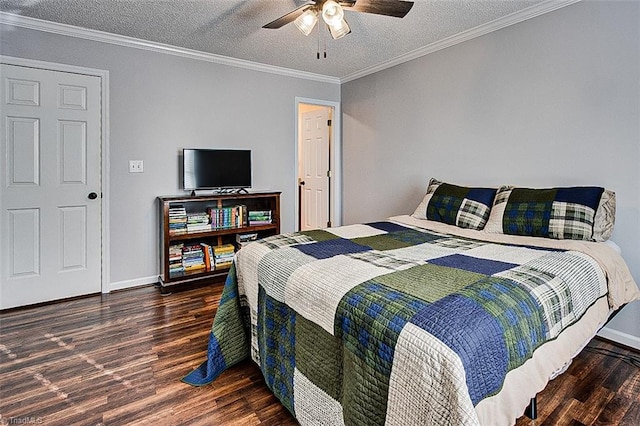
[0,64,101,309]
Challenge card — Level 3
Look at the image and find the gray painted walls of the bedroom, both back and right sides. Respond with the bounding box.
[0,1,640,342]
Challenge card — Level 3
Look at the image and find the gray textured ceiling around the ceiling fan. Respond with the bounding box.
[0,0,564,79]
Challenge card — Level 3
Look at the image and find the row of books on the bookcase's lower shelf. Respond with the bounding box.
[169,243,235,277]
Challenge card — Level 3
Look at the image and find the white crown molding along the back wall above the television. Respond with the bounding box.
[0,12,340,84]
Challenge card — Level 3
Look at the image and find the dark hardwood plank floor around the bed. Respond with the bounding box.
[0,285,640,426]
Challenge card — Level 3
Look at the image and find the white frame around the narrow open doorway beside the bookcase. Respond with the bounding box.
[293,96,342,231]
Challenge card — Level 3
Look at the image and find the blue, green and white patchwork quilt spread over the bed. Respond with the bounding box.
[184,221,607,425]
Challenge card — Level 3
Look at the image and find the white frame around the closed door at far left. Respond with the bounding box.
[0,55,111,293]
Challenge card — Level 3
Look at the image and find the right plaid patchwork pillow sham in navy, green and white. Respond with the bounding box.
[484,186,615,241]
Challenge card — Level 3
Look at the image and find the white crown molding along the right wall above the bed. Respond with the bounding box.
[340,0,581,84]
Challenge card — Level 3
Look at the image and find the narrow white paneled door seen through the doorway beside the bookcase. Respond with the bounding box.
[300,107,330,231]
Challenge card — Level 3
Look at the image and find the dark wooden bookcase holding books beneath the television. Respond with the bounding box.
[158,192,280,293]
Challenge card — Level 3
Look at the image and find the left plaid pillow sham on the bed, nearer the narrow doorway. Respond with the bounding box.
[412,178,496,230]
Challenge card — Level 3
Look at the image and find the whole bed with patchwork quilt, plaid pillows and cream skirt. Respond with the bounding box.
[184,179,640,425]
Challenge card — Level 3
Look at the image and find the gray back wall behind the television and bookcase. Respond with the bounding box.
[0,26,340,288]
